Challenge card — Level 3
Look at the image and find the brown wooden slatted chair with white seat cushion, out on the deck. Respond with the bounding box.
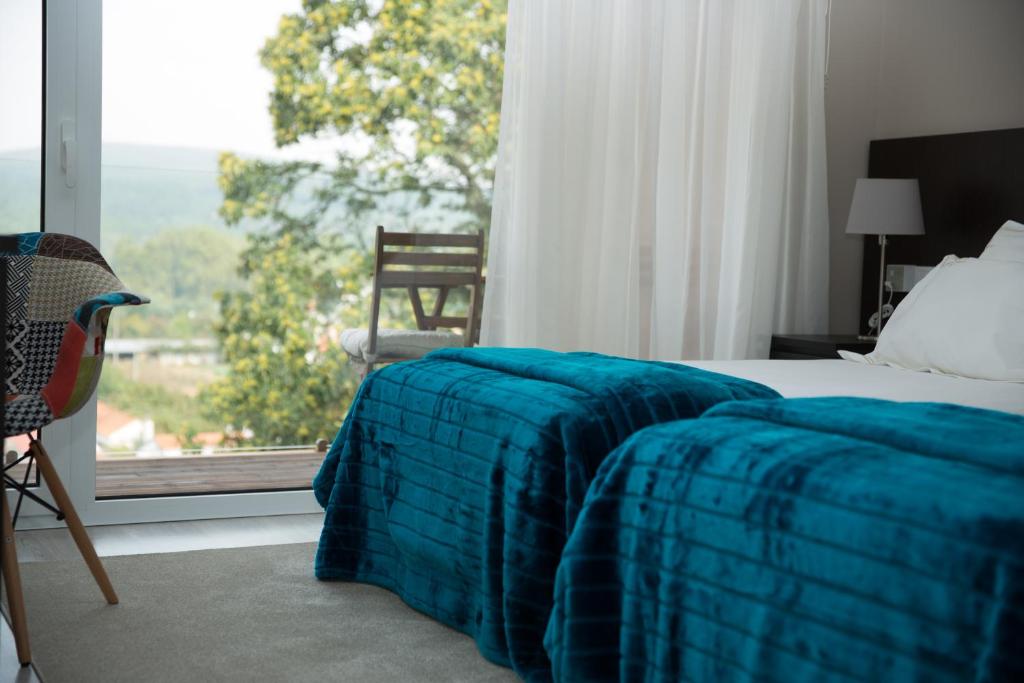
[341,226,483,379]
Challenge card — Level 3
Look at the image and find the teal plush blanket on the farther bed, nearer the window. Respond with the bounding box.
[313,348,777,680]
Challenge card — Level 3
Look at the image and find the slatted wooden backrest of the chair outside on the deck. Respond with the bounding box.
[369,226,483,354]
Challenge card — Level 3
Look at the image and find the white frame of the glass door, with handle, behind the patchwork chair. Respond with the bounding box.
[14,0,321,528]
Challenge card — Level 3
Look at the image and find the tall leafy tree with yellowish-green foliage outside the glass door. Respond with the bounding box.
[203,0,506,444]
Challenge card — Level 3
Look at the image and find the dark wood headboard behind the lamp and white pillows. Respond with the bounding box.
[859,128,1024,331]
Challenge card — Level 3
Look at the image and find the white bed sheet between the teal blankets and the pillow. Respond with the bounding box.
[684,358,1024,415]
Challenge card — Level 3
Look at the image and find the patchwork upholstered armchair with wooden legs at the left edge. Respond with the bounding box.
[0,232,147,665]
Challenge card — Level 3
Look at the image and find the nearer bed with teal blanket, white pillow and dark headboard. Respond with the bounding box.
[545,129,1024,681]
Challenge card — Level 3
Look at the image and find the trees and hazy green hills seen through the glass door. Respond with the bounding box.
[0,0,506,445]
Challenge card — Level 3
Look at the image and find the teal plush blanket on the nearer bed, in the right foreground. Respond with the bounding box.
[545,398,1024,682]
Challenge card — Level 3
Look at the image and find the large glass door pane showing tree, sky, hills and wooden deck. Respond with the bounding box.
[96,0,505,498]
